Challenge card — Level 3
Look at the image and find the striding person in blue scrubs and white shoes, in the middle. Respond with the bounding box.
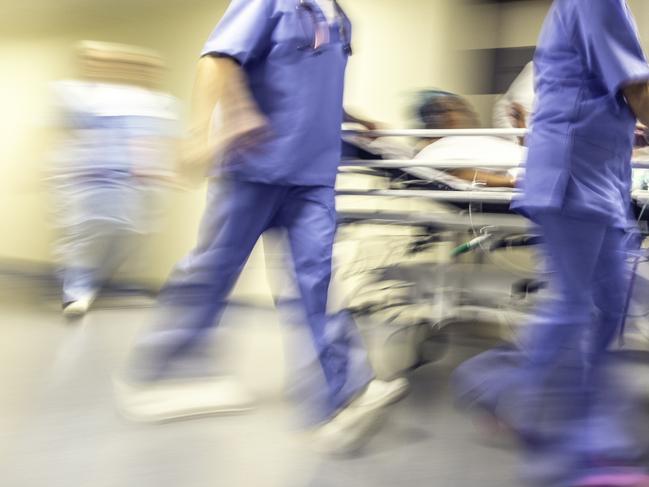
[118,0,407,451]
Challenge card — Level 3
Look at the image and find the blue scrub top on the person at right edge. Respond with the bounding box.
[512,0,649,227]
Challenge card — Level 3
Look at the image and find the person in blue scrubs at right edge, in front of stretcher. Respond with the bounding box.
[456,0,649,487]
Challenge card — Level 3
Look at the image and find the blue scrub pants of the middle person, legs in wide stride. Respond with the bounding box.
[134,180,373,419]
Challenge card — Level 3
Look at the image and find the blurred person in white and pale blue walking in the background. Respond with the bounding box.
[49,42,178,317]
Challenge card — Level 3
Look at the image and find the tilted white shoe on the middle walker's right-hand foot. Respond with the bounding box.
[315,378,409,454]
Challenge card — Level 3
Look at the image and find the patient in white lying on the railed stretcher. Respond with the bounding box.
[346,92,526,190]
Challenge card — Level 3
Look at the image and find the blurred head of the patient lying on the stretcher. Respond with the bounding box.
[417,91,480,130]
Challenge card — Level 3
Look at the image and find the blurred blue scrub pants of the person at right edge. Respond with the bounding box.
[454,213,641,486]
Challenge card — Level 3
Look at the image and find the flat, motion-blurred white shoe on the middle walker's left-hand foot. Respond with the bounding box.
[114,377,254,422]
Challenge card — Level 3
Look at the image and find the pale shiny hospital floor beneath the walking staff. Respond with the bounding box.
[0,288,648,487]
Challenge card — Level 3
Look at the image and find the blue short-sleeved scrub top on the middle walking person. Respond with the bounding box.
[202,0,351,186]
